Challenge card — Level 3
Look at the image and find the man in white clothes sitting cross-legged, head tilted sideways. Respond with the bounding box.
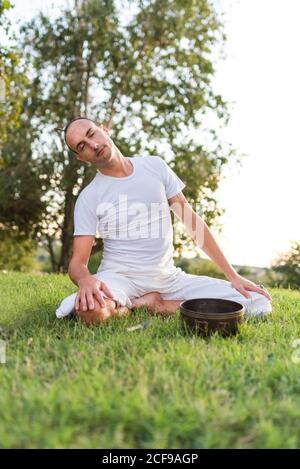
[56,117,272,323]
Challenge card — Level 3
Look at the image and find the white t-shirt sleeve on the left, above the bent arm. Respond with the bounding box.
[73,193,98,236]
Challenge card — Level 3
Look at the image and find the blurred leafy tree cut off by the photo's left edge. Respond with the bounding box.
[0,0,35,270]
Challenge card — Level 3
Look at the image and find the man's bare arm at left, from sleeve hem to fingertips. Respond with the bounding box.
[68,236,113,311]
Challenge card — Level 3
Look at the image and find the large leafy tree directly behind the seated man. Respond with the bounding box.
[1,0,234,271]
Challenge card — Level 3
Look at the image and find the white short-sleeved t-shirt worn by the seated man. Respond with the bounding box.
[74,156,185,275]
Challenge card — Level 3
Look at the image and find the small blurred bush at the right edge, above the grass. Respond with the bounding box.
[272,241,300,288]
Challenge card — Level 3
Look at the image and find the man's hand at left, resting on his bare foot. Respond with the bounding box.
[75,275,113,311]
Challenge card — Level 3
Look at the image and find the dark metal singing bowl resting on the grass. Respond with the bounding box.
[180,298,245,337]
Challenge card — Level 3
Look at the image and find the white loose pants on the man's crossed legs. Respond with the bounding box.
[56,268,272,318]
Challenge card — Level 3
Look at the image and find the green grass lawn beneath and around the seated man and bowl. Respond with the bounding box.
[0,273,300,448]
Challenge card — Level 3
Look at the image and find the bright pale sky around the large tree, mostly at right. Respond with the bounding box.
[5,0,300,266]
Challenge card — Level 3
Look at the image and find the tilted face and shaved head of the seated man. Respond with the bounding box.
[66,119,113,166]
